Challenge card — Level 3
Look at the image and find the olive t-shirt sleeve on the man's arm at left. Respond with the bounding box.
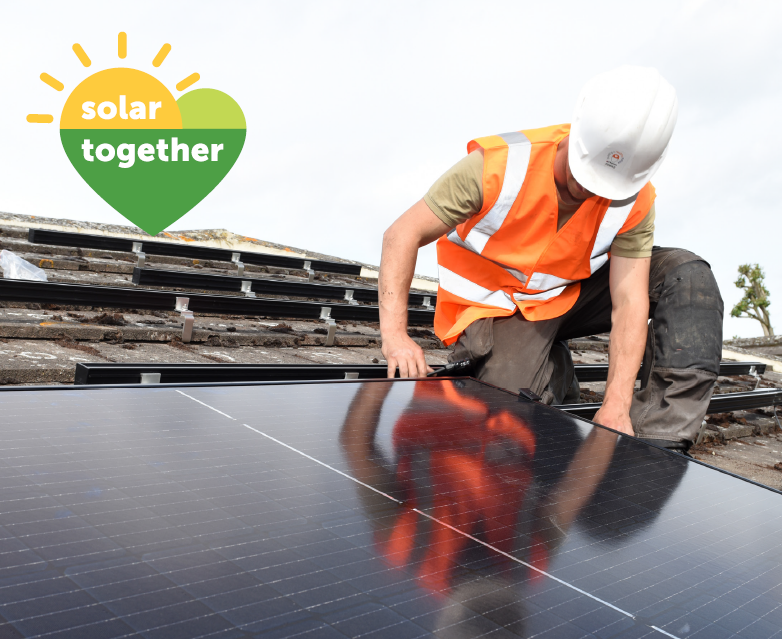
[424,151,483,228]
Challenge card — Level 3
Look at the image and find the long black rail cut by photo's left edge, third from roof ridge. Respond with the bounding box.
[0,279,434,326]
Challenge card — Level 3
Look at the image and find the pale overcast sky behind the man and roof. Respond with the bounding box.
[0,0,782,337]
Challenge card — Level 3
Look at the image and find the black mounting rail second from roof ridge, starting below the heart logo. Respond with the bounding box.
[133,267,437,306]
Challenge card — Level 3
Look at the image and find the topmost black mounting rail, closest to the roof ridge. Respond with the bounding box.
[27,229,361,275]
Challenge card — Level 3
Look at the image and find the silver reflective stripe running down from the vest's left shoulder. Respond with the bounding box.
[465,131,532,255]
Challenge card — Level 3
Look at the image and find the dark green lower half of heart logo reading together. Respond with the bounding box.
[60,130,246,235]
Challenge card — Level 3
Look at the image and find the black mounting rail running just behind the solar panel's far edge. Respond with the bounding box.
[75,362,766,384]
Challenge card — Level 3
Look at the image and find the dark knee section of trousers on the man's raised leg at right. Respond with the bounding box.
[652,260,724,374]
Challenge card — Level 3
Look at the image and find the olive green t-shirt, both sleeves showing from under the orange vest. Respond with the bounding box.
[424,152,654,257]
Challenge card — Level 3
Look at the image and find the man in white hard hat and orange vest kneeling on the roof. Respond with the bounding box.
[379,66,723,452]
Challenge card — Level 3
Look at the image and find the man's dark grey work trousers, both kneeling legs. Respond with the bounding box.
[449,246,723,449]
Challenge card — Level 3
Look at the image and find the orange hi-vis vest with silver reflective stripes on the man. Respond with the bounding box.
[434,124,655,344]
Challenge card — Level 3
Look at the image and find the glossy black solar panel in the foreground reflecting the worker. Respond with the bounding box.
[0,379,782,639]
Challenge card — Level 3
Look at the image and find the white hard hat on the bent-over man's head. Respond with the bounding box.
[568,65,679,200]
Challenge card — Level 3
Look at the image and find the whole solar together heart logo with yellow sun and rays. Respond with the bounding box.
[27,33,247,235]
